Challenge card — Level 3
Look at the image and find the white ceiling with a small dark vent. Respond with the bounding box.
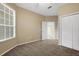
[16,3,65,16]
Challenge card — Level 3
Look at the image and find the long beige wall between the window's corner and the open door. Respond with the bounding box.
[17,5,44,44]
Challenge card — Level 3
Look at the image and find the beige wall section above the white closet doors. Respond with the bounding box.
[58,3,79,15]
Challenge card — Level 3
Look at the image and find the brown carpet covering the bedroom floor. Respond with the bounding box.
[4,40,79,56]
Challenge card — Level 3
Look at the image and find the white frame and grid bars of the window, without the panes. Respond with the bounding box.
[0,3,16,42]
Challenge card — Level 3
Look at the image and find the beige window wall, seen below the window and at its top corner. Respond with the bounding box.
[0,4,16,54]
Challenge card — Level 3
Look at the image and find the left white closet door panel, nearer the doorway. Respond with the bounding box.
[61,16,73,48]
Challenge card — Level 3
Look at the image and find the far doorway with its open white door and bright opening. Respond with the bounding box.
[42,21,56,40]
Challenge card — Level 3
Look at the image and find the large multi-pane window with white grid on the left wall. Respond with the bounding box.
[0,4,15,42]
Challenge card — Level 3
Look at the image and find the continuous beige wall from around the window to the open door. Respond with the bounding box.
[0,3,45,55]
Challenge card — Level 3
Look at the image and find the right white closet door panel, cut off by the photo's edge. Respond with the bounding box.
[72,14,79,50]
